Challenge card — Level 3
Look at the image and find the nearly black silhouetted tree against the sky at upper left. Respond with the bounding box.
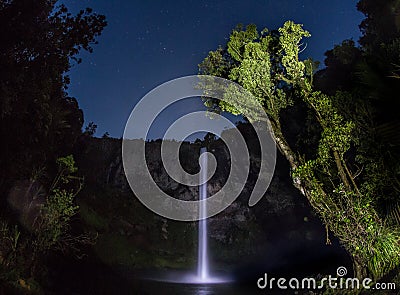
[0,0,106,188]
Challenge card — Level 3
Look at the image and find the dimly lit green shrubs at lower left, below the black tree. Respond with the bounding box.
[0,156,86,291]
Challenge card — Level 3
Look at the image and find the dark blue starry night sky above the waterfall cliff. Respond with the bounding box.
[62,0,363,138]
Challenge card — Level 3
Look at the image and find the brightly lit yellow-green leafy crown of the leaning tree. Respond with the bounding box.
[199,22,309,125]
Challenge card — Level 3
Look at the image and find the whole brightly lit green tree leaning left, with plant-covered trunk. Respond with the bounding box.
[200,21,400,279]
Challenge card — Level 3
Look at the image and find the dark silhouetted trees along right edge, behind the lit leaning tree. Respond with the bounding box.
[316,0,400,225]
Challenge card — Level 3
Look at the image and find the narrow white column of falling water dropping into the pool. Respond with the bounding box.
[197,147,209,281]
